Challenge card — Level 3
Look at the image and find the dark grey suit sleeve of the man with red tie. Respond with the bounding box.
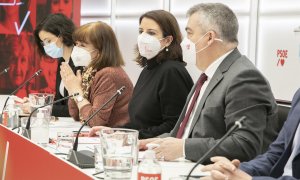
[185,69,275,163]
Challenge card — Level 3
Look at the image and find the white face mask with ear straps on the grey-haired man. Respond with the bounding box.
[180,32,223,64]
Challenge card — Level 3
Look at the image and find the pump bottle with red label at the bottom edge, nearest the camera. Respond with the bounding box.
[138,143,161,180]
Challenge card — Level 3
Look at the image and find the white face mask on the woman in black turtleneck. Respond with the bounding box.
[137,33,164,59]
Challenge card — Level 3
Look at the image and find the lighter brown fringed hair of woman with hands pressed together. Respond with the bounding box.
[73,21,124,70]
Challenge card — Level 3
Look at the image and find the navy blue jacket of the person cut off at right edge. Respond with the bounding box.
[240,89,300,180]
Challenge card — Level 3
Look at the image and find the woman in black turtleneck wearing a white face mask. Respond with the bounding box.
[90,10,193,139]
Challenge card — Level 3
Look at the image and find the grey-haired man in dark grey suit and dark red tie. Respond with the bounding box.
[140,3,279,161]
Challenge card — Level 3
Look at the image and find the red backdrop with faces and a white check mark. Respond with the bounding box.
[0,0,80,97]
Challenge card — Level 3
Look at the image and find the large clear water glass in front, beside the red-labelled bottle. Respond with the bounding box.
[100,128,138,179]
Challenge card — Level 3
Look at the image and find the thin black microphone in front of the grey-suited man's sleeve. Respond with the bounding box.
[186,116,246,180]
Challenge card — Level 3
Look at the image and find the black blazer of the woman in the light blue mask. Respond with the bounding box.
[52,58,83,117]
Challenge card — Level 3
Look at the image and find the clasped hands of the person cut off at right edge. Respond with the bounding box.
[200,156,252,180]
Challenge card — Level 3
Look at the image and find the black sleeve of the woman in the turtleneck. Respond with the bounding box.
[125,68,193,139]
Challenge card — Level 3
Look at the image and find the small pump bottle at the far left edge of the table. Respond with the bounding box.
[2,96,19,128]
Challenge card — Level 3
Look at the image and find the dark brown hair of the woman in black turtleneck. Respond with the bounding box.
[135,10,183,67]
